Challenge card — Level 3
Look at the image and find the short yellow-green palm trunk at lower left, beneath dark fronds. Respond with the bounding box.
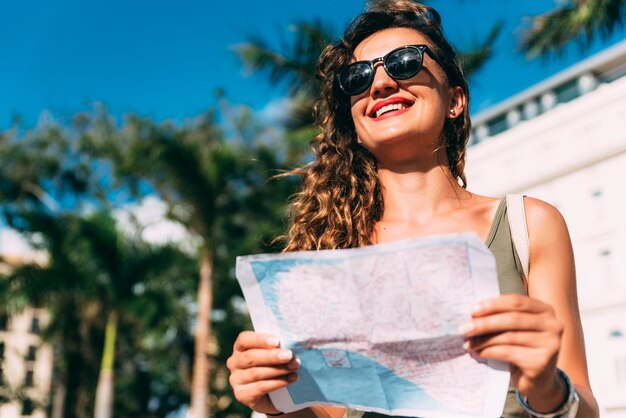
[93,310,117,418]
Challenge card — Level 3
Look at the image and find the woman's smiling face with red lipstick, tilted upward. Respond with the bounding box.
[351,28,465,162]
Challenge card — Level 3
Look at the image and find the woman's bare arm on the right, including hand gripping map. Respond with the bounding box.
[464,198,598,418]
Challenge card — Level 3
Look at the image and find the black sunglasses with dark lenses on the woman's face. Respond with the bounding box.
[337,45,443,96]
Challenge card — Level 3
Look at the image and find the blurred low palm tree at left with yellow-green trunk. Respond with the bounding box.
[0,211,197,417]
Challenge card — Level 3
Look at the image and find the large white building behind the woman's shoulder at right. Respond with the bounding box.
[466,41,626,418]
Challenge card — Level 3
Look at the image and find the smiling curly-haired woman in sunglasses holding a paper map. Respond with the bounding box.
[228,0,598,418]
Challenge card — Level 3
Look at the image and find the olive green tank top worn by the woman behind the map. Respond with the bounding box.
[344,199,530,418]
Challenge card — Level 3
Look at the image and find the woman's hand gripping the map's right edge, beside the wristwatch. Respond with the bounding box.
[461,294,565,410]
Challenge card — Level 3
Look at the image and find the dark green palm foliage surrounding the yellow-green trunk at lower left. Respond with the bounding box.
[0,207,196,417]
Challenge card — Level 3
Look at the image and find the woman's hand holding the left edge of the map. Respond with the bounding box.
[226,331,300,414]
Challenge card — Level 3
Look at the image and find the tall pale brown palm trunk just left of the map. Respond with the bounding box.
[187,248,213,418]
